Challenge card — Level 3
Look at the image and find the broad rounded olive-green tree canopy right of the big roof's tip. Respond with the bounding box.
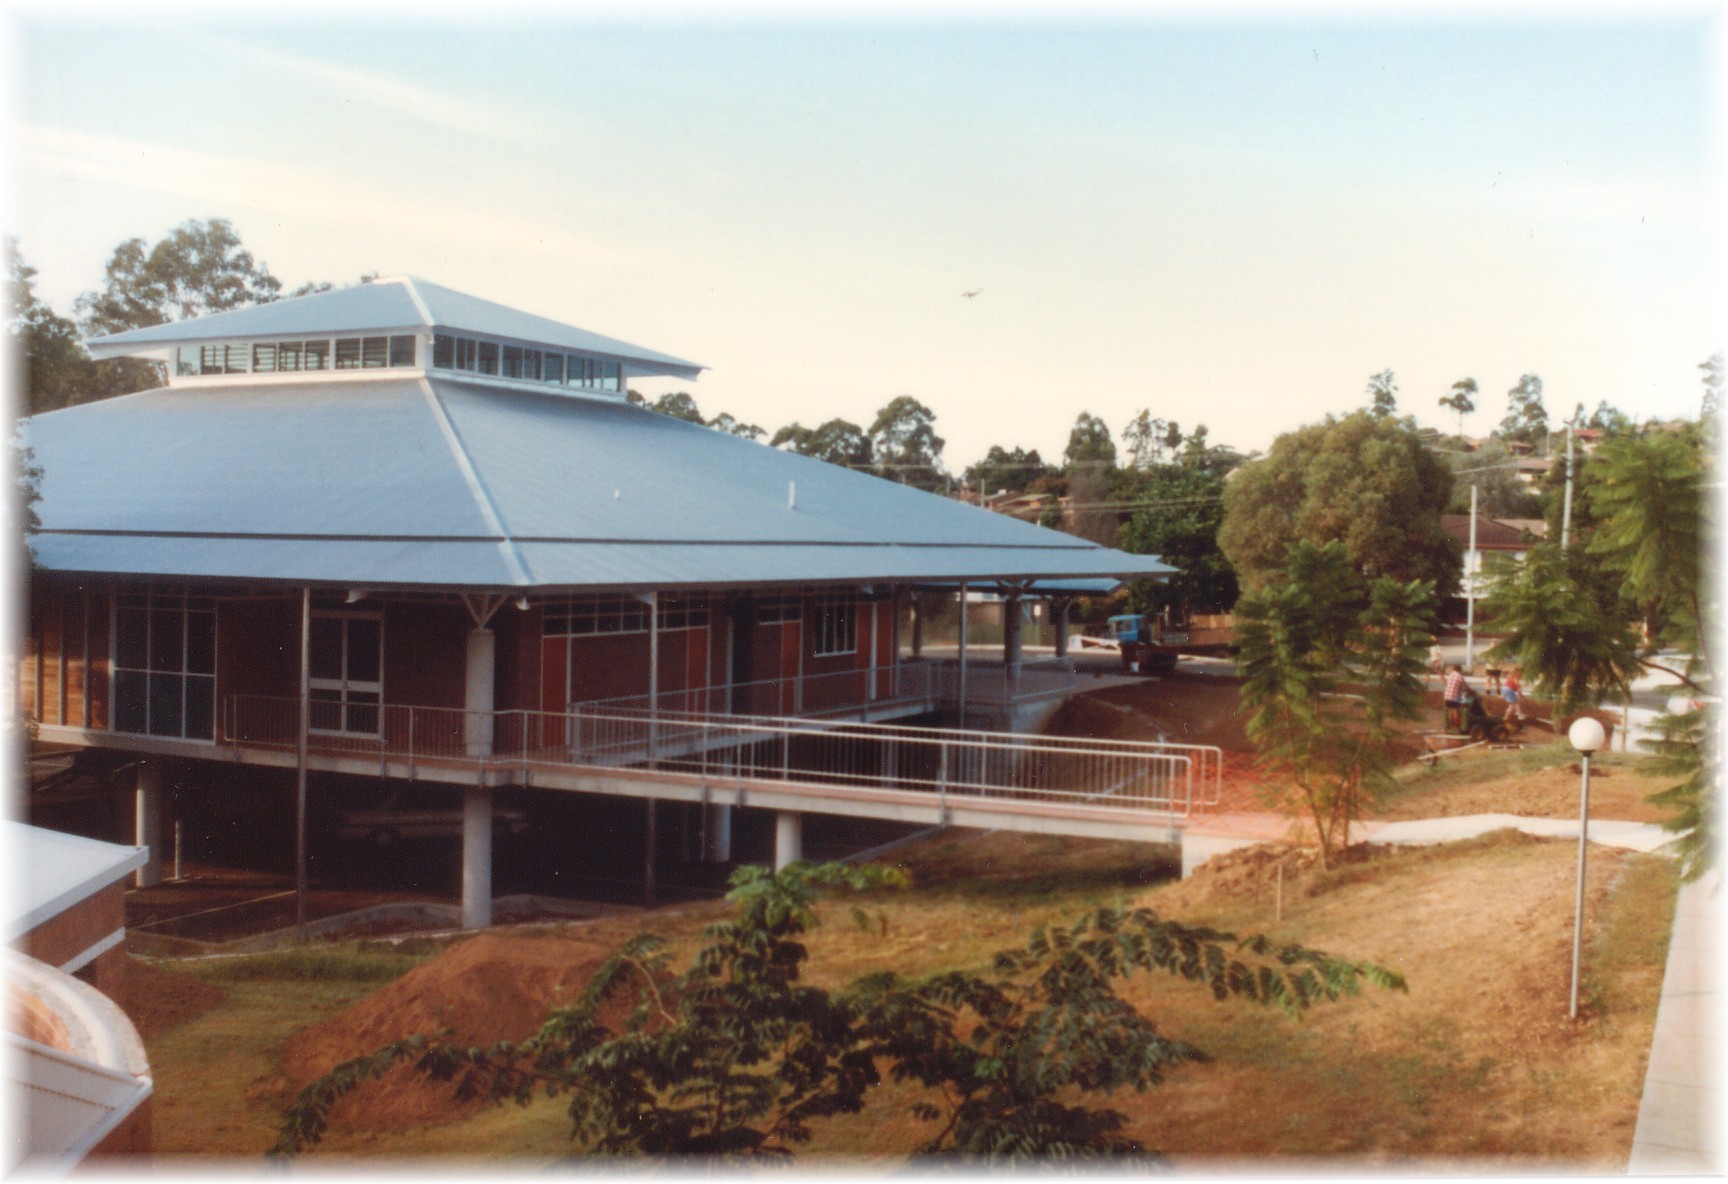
[1218,411,1462,598]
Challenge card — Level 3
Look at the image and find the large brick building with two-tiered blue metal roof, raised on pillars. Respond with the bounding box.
[17,278,1173,925]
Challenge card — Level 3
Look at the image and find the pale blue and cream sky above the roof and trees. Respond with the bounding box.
[3,5,1728,472]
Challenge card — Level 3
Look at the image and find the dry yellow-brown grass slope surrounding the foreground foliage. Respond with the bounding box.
[150,822,1674,1170]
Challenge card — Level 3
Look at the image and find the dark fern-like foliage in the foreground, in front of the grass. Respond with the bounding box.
[273,864,1405,1165]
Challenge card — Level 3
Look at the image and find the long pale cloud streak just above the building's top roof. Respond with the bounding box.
[17,124,646,266]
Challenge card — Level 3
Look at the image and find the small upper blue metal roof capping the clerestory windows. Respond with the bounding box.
[86,277,703,379]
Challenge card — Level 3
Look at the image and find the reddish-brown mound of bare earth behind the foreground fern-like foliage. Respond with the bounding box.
[282,933,634,1130]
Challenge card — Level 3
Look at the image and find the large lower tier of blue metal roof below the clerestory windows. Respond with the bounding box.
[24,373,1173,589]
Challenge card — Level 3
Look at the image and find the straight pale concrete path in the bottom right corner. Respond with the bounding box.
[1626,871,1723,1175]
